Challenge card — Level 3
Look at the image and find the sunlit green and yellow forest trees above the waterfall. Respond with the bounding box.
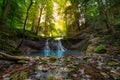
[0,0,120,37]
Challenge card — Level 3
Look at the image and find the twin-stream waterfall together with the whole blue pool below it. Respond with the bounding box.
[25,39,82,57]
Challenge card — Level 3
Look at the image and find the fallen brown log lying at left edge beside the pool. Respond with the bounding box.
[0,52,30,61]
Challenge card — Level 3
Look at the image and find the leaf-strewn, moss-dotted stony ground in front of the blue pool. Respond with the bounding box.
[0,53,120,80]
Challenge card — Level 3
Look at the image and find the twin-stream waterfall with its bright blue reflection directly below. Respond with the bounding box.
[44,39,66,56]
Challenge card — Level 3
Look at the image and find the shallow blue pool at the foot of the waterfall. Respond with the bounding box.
[24,50,83,57]
